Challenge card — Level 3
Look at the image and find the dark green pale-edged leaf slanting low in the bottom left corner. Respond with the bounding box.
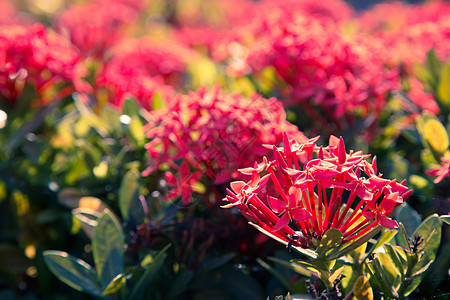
[43,250,102,297]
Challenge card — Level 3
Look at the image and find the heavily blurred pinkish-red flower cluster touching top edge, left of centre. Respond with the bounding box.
[55,0,142,58]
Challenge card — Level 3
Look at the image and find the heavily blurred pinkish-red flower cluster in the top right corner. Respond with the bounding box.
[358,1,450,67]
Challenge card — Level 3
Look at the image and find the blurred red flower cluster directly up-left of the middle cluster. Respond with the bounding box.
[96,38,193,109]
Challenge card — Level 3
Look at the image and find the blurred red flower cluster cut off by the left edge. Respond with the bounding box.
[0,24,79,103]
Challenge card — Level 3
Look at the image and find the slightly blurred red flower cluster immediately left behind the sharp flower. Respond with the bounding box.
[144,86,306,203]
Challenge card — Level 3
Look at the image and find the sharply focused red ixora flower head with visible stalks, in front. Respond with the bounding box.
[223,134,412,248]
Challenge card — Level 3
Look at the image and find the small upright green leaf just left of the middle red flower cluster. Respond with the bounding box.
[119,169,145,224]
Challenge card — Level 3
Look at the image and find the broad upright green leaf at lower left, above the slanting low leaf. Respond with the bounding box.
[92,209,125,287]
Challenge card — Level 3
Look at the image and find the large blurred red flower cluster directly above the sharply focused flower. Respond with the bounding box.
[236,10,398,130]
